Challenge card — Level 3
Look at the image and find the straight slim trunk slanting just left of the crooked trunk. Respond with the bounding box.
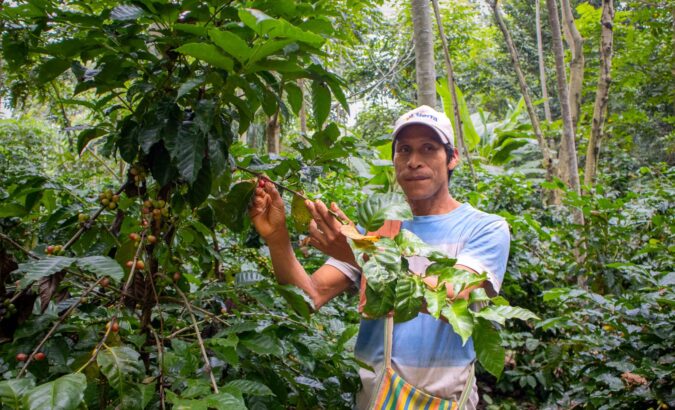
[546,0,583,202]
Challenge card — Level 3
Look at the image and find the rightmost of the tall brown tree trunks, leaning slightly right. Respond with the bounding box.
[584,0,614,187]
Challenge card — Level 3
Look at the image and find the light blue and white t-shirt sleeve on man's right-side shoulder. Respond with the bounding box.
[456,218,511,296]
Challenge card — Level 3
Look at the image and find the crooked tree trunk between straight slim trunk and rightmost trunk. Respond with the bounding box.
[561,0,584,130]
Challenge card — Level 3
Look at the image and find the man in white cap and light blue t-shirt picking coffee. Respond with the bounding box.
[250,106,510,409]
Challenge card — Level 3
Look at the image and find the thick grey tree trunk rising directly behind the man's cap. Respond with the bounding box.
[411,0,436,108]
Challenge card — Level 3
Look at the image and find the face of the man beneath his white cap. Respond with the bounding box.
[394,124,457,201]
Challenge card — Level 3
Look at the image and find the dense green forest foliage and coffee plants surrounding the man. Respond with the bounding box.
[0,0,675,409]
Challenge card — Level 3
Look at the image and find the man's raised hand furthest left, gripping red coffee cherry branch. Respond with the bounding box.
[248,177,288,242]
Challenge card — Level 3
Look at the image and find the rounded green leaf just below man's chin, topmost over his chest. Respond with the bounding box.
[357,193,412,232]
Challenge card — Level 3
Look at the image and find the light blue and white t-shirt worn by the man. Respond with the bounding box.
[326,203,510,408]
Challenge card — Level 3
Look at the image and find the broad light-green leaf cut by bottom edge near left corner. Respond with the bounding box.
[24,373,87,410]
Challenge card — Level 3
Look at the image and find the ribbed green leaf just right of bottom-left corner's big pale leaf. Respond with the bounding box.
[96,346,144,394]
